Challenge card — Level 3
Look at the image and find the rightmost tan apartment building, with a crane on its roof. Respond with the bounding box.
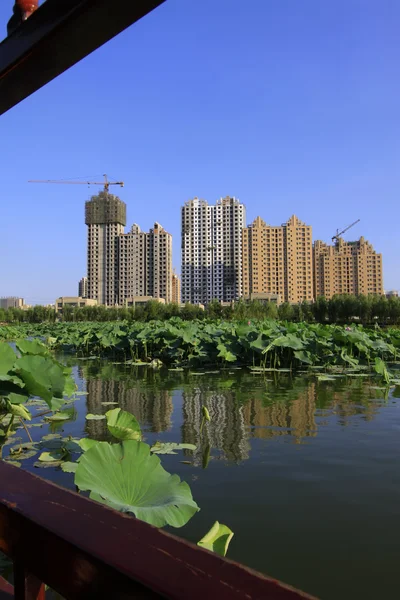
[314,237,384,299]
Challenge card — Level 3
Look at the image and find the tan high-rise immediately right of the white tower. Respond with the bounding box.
[243,215,313,304]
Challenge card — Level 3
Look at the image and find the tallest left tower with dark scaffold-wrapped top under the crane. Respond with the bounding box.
[85,190,126,306]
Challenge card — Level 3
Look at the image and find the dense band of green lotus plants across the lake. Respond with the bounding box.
[0,317,400,369]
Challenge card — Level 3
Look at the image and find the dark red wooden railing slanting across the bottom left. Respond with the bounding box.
[0,461,318,600]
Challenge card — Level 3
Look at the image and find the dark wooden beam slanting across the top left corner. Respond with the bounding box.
[0,0,165,115]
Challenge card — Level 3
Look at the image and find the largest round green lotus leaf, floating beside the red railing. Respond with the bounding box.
[75,440,199,527]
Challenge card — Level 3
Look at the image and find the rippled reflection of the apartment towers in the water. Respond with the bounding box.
[77,360,378,464]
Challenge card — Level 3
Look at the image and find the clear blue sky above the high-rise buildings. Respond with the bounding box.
[0,0,400,303]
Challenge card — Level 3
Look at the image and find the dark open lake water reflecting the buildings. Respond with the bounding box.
[7,357,400,600]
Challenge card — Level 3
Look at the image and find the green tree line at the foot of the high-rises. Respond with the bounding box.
[0,295,400,325]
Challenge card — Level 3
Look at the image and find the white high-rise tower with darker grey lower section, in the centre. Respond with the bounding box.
[181,196,246,304]
